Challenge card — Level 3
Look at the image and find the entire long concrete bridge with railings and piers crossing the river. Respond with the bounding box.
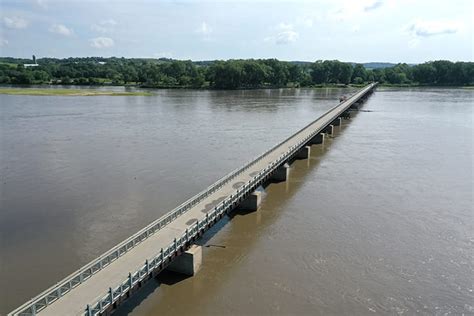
[9,83,377,316]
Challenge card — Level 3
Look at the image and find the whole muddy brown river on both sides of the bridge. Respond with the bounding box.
[0,88,474,315]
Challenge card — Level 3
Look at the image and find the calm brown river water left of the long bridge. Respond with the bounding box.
[0,88,354,314]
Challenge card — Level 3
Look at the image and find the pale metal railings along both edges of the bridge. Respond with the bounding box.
[9,83,377,315]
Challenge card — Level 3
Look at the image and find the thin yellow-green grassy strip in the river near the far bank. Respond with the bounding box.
[0,88,152,96]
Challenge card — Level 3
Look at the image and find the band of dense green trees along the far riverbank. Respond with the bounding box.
[0,57,474,89]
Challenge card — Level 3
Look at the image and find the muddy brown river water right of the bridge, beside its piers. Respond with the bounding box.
[118,88,474,316]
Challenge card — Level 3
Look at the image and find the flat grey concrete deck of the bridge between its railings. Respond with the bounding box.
[11,85,373,315]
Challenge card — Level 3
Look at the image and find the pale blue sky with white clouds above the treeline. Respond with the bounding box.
[0,0,474,63]
